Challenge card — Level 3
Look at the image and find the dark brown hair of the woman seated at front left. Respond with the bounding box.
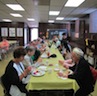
[13,46,26,58]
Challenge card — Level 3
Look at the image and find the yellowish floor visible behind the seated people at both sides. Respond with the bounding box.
[0,54,97,96]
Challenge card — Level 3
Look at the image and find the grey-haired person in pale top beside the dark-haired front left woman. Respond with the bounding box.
[23,46,35,68]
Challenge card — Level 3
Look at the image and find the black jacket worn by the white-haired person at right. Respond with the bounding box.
[68,58,94,92]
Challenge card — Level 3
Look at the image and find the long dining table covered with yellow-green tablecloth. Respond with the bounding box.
[26,45,79,91]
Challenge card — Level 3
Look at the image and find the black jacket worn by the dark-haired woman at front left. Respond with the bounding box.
[2,60,26,93]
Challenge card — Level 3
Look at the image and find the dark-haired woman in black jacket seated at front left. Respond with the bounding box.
[2,47,31,96]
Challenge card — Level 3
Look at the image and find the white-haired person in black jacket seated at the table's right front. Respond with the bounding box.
[59,48,94,96]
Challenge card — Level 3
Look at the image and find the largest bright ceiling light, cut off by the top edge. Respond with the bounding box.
[65,0,85,7]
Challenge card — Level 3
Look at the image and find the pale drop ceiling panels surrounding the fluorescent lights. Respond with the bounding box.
[0,0,97,27]
